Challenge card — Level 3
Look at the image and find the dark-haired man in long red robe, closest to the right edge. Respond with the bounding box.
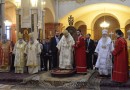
[112,29,128,83]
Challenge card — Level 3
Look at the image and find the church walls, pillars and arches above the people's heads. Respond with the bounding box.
[1,0,130,42]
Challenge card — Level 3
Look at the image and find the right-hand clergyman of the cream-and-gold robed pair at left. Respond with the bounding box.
[25,33,41,74]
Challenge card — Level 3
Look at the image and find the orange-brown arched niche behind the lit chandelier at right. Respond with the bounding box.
[91,13,120,40]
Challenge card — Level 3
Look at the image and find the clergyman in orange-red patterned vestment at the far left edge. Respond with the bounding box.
[0,34,12,72]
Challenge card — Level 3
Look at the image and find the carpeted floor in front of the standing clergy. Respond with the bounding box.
[0,70,130,90]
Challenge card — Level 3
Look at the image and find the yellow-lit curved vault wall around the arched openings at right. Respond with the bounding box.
[59,3,130,37]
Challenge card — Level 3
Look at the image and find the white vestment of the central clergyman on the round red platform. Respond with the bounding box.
[57,34,75,69]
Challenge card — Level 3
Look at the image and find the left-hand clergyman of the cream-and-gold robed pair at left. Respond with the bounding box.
[13,32,26,73]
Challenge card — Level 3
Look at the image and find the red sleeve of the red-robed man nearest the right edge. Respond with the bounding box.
[112,40,124,56]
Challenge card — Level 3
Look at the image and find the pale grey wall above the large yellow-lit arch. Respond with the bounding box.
[58,0,130,19]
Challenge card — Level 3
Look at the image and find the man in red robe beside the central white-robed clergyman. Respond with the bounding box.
[74,30,87,73]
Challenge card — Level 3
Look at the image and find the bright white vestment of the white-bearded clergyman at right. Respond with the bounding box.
[95,37,114,75]
